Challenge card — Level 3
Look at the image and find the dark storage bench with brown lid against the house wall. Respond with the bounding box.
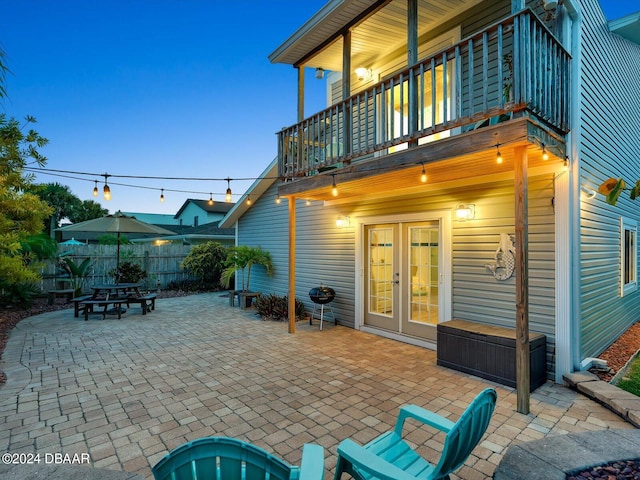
[437,320,547,391]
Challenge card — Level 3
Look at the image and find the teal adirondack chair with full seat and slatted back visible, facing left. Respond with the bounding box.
[335,388,497,480]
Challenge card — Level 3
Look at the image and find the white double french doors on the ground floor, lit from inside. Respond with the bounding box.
[361,212,451,342]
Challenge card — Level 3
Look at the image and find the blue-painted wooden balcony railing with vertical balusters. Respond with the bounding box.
[278,10,570,178]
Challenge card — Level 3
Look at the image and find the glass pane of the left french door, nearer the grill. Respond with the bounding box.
[367,228,393,317]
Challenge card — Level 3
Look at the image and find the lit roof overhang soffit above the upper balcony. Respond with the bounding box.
[269,0,480,71]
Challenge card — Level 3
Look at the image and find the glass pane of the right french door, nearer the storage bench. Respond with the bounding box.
[409,227,439,325]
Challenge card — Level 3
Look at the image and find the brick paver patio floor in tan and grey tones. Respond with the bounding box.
[0,293,633,479]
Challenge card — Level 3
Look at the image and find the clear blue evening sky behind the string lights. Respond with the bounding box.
[0,0,640,213]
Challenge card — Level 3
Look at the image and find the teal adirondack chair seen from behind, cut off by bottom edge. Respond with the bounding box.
[151,437,324,480]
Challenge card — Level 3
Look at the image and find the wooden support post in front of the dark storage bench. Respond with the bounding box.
[513,146,531,415]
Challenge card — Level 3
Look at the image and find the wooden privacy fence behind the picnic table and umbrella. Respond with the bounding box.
[41,244,193,292]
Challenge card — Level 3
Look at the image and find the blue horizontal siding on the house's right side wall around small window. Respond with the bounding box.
[580,0,640,358]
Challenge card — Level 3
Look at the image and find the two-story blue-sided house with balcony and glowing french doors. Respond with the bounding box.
[220,0,640,382]
